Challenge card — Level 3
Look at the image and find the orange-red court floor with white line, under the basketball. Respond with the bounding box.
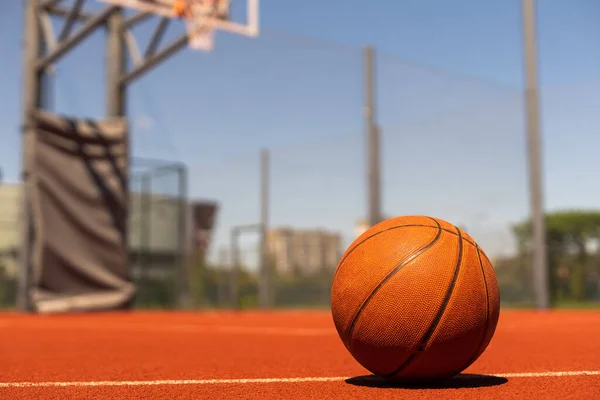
[0,310,600,400]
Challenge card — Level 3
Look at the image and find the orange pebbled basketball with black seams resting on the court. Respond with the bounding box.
[331,216,500,381]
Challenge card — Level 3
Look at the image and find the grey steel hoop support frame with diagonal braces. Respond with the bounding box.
[17,0,258,312]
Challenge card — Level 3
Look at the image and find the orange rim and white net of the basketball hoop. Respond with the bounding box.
[173,0,229,51]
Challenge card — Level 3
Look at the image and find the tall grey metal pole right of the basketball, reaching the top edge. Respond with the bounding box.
[522,0,550,309]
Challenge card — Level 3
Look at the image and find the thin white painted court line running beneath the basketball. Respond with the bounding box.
[0,371,600,389]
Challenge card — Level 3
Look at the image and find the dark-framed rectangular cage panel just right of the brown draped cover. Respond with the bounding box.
[129,159,187,308]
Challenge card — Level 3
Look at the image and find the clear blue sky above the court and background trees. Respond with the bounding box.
[0,0,600,264]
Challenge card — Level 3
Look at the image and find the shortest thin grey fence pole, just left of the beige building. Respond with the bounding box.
[259,149,270,309]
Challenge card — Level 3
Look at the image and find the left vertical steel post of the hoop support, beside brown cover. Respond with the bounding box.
[17,0,44,311]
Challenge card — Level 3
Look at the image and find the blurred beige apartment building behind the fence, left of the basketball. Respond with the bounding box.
[267,228,342,274]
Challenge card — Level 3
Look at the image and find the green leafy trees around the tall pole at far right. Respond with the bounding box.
[513,210,600,303]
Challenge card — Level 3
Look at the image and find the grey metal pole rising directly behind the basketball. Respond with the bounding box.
[364,46,382,226]
